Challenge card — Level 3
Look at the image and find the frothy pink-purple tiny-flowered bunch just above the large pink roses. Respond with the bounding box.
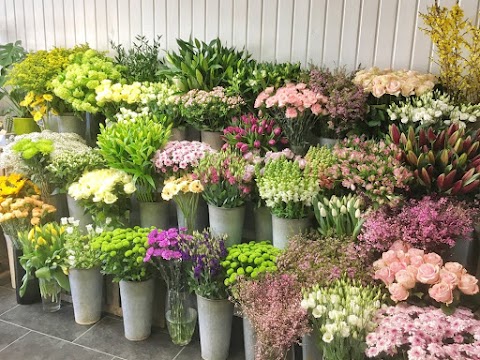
[358,196,479,253]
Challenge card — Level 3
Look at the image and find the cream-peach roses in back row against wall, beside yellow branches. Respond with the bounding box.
[353,67,437,98]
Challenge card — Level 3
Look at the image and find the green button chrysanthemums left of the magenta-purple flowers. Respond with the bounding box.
[92,226,153,281]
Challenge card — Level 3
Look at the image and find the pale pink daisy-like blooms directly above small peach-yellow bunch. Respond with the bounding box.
[152,141,213,178]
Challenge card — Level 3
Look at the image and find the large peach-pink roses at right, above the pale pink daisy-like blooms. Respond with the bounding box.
[373,241,479,306]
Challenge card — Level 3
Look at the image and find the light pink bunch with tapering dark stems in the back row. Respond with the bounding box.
[254,83,328,155]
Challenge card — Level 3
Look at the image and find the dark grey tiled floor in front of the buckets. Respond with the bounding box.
[0,277,244,360]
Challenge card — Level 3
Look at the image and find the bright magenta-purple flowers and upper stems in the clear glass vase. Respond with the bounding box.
[143,228,192,288]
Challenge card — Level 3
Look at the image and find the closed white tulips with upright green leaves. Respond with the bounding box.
[313,194,365,238]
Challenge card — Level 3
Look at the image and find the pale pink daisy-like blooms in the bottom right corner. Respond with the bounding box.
[365,303,480,360]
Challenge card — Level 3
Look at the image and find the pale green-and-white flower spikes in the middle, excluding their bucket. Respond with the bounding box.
[256,149,320,219]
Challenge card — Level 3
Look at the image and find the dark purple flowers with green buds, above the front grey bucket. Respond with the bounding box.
[183,230,228,299]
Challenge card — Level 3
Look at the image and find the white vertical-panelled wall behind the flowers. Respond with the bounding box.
[0,0,480,72]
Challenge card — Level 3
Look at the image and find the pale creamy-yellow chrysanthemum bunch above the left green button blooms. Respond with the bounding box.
[68,168,135,228]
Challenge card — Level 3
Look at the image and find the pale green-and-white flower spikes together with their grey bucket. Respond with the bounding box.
[256,149,320,249]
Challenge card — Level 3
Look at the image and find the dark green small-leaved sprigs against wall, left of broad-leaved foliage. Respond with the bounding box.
[110,35,163,83]
